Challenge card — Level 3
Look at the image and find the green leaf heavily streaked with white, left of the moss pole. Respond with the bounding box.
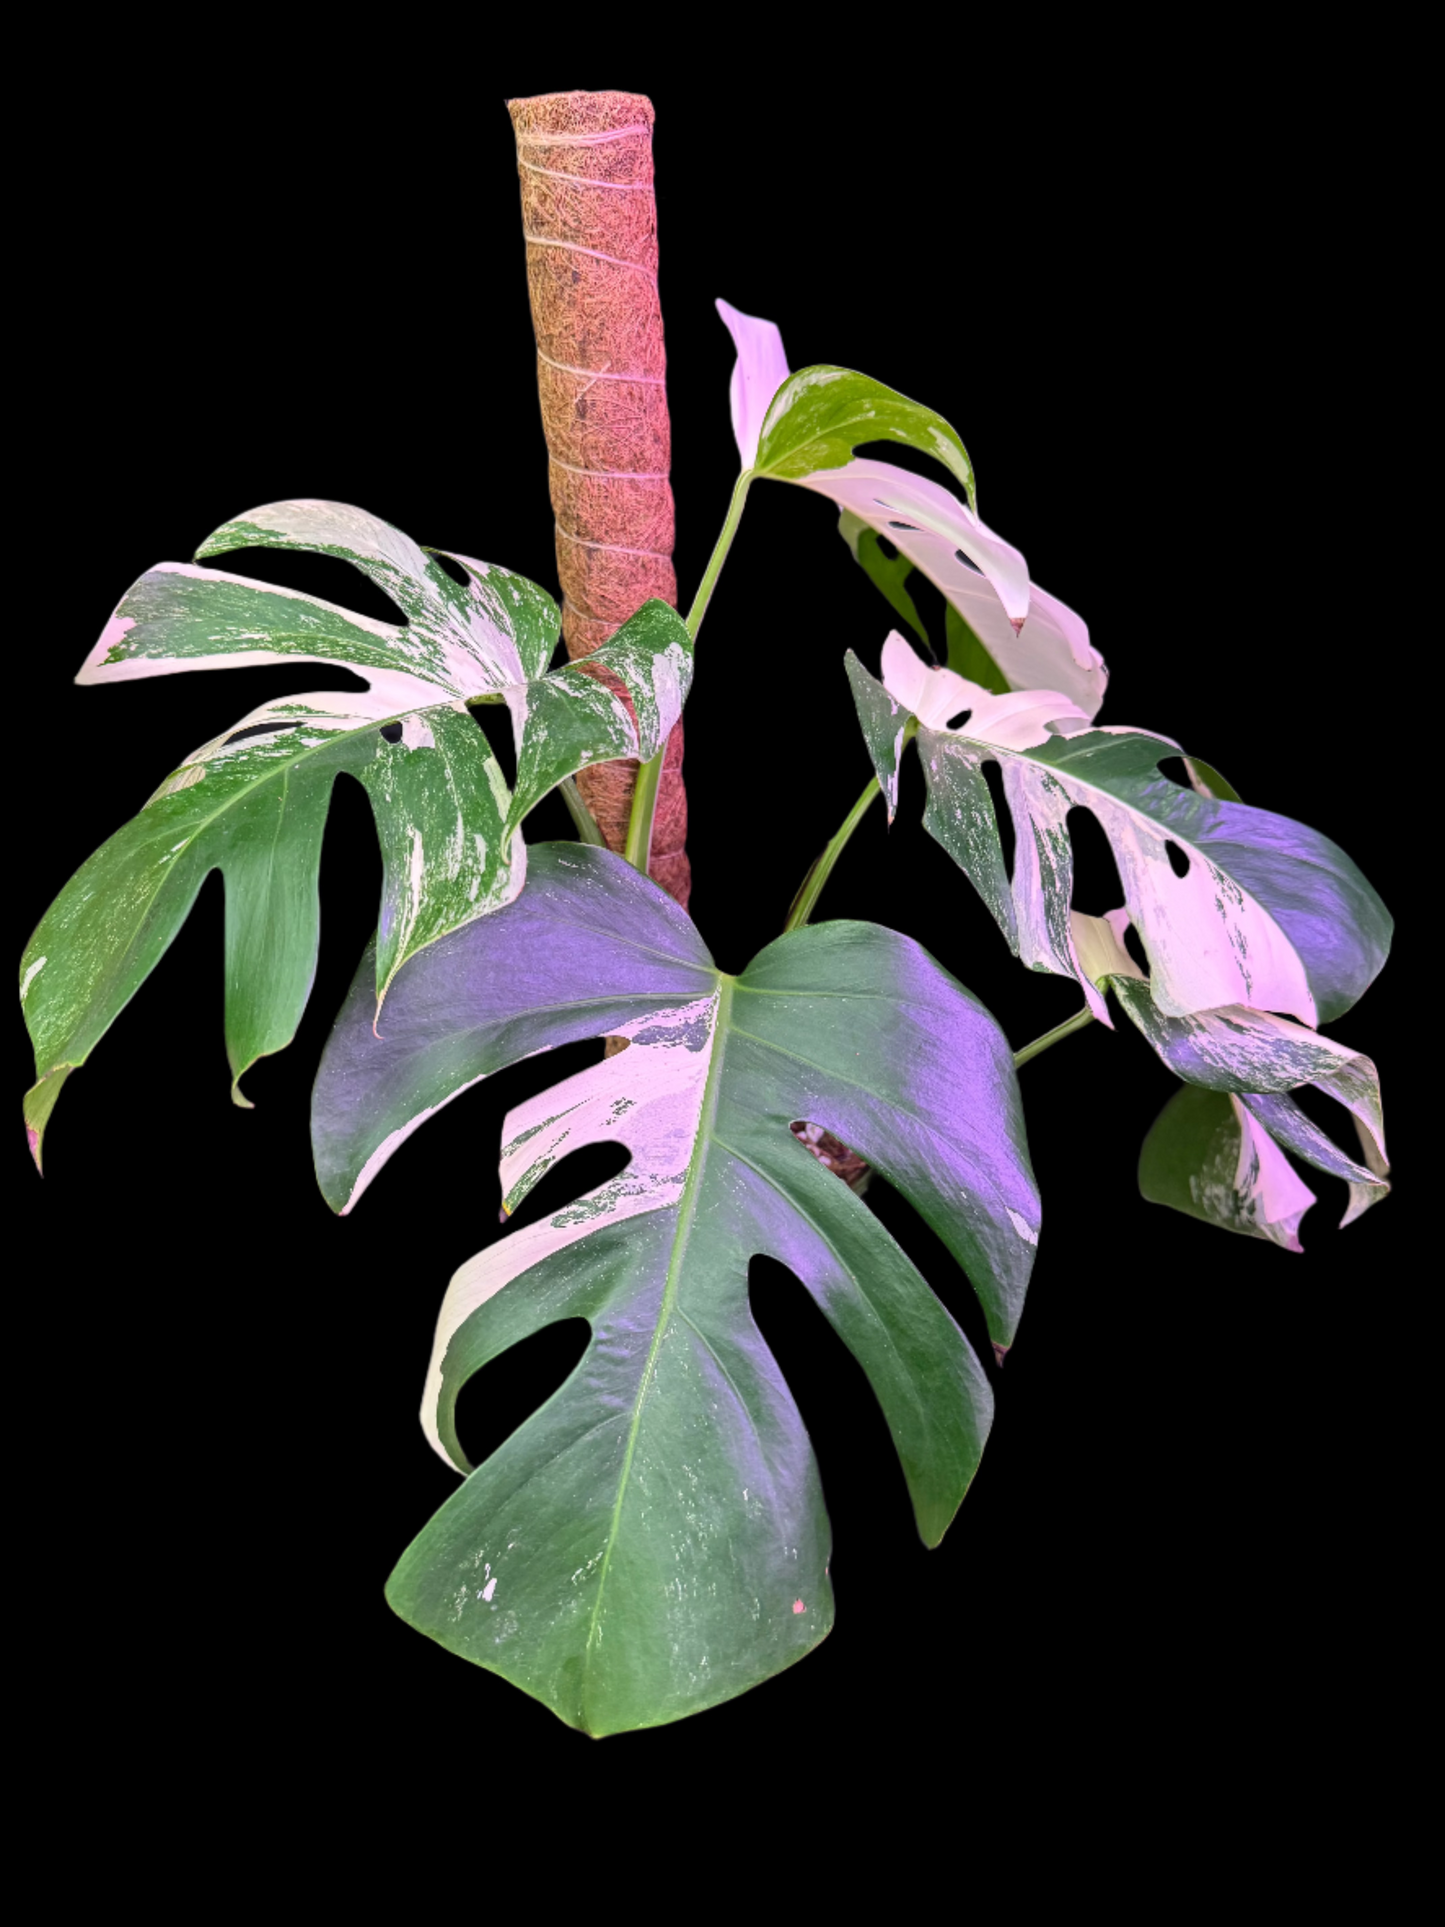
[21,501,692,1162]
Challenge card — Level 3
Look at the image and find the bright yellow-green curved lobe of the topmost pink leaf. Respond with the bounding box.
[753,366,979,515]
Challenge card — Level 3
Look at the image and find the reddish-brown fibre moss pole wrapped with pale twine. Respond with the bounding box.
[507,92,692,906]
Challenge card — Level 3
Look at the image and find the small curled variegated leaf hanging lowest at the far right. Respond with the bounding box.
[1073,910,1389,1251]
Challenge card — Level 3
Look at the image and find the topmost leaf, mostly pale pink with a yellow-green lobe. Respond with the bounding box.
[717,301,1108,717]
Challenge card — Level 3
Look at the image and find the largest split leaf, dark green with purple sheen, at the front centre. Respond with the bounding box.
[312,844,1038,1734]
